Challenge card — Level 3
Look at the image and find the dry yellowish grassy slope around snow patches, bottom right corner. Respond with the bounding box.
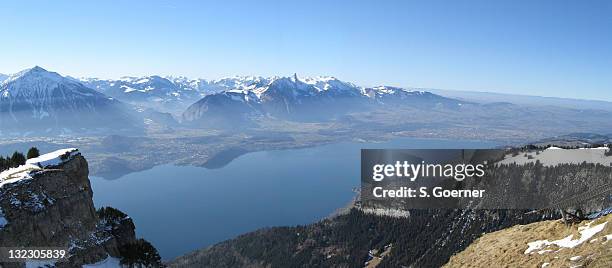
[445,214,612,267]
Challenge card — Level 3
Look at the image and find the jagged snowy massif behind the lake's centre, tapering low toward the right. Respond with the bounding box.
[182,75,461,124]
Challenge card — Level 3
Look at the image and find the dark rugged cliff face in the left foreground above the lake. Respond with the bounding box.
[0,153,136,267]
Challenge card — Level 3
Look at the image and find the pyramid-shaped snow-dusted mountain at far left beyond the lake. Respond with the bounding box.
[0,66,137,135]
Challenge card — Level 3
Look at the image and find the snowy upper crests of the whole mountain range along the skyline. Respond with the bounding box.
[0,66,450,107]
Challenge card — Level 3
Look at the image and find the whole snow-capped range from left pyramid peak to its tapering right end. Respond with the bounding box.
[0,66,461,136]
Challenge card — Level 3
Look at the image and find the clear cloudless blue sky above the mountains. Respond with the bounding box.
[0,0,612,100]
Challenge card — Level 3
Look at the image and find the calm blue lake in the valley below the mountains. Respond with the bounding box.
[91,138,495,259]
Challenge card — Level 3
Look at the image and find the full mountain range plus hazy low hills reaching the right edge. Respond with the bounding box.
[0,67,612,138]
